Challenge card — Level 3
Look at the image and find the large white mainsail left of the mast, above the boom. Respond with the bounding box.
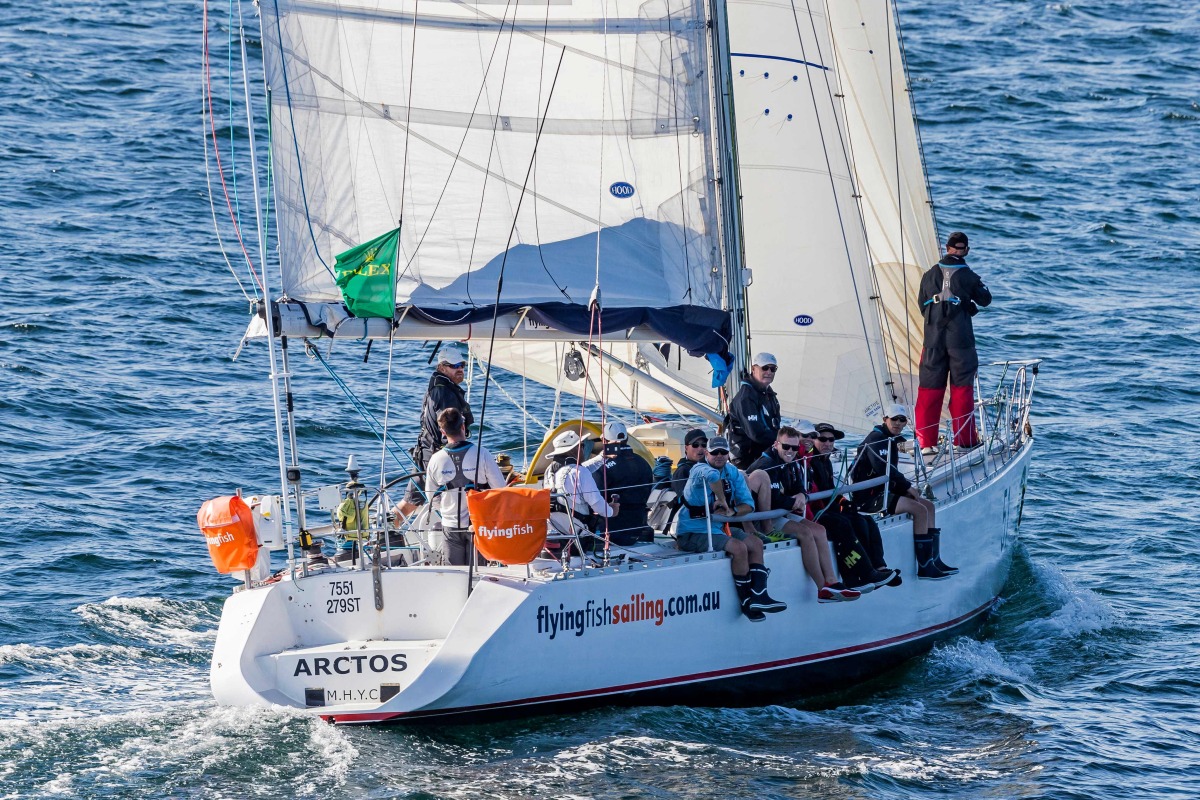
[262,0,721,309]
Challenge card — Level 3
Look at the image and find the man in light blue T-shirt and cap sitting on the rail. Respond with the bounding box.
[676,437,787,622]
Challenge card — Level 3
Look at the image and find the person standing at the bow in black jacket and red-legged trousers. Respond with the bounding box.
[914,230,991,455]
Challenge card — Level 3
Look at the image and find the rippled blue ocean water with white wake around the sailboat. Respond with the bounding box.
[0,0,1200,800]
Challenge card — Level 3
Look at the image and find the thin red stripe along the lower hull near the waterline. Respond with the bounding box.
[320,597,996,723]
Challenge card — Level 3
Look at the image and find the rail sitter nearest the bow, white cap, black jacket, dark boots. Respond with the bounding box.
[851,403,958,581]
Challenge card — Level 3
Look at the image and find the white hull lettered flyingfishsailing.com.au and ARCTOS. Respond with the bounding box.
[211,440,1032,723]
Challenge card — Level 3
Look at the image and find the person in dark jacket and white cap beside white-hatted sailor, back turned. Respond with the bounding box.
[583,421,654,547]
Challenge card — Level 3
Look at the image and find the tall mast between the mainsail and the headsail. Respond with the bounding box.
[709,0,751,392]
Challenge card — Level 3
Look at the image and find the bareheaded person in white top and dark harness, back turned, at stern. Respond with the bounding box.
[425,408,506,566]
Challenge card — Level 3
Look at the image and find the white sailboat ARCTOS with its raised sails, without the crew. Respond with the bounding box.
[202,0,1037,723]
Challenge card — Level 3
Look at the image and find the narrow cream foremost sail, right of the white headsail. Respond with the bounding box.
[828,0,940,403]
